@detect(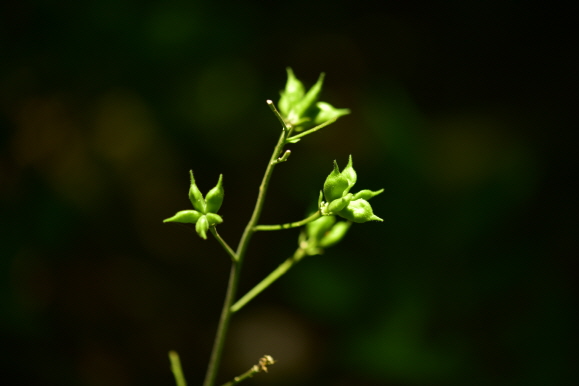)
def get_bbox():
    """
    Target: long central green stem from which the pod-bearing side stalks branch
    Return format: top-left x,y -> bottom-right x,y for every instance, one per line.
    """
203,113 -> 289,386
